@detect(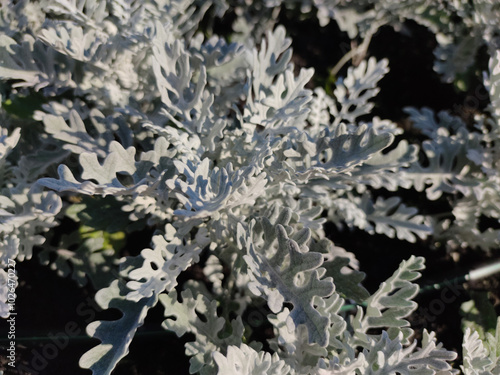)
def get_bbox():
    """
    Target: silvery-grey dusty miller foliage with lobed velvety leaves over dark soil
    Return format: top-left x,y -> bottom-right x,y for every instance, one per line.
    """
0,0 -> 500,375
